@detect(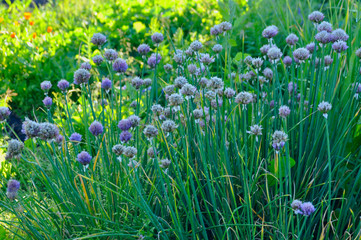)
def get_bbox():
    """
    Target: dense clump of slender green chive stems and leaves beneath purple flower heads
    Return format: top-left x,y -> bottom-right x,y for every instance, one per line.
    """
0,0 -> 361,239
